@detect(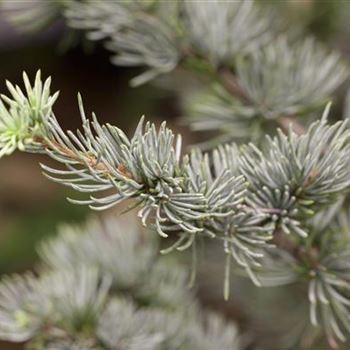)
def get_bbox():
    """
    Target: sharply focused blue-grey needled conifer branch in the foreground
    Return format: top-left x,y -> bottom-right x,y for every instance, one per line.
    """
4,72 -> 350,314
